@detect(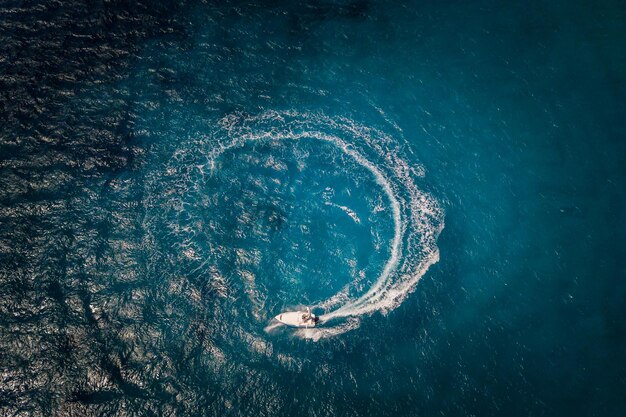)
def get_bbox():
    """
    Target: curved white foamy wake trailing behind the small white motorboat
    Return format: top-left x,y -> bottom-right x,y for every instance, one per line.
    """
208,112 -> 443,340
